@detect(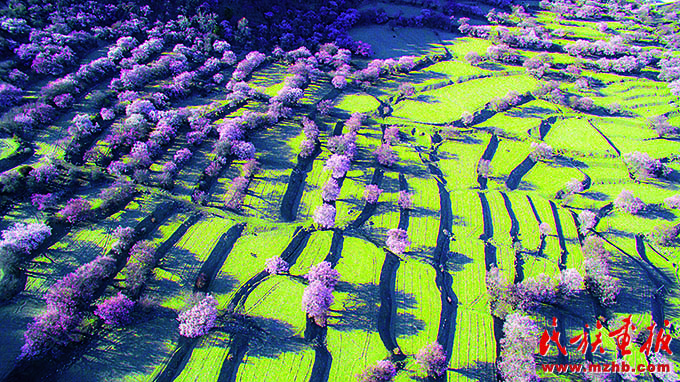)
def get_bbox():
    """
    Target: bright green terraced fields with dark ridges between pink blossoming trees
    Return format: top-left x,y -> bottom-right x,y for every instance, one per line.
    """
0,1 -> 680,382
